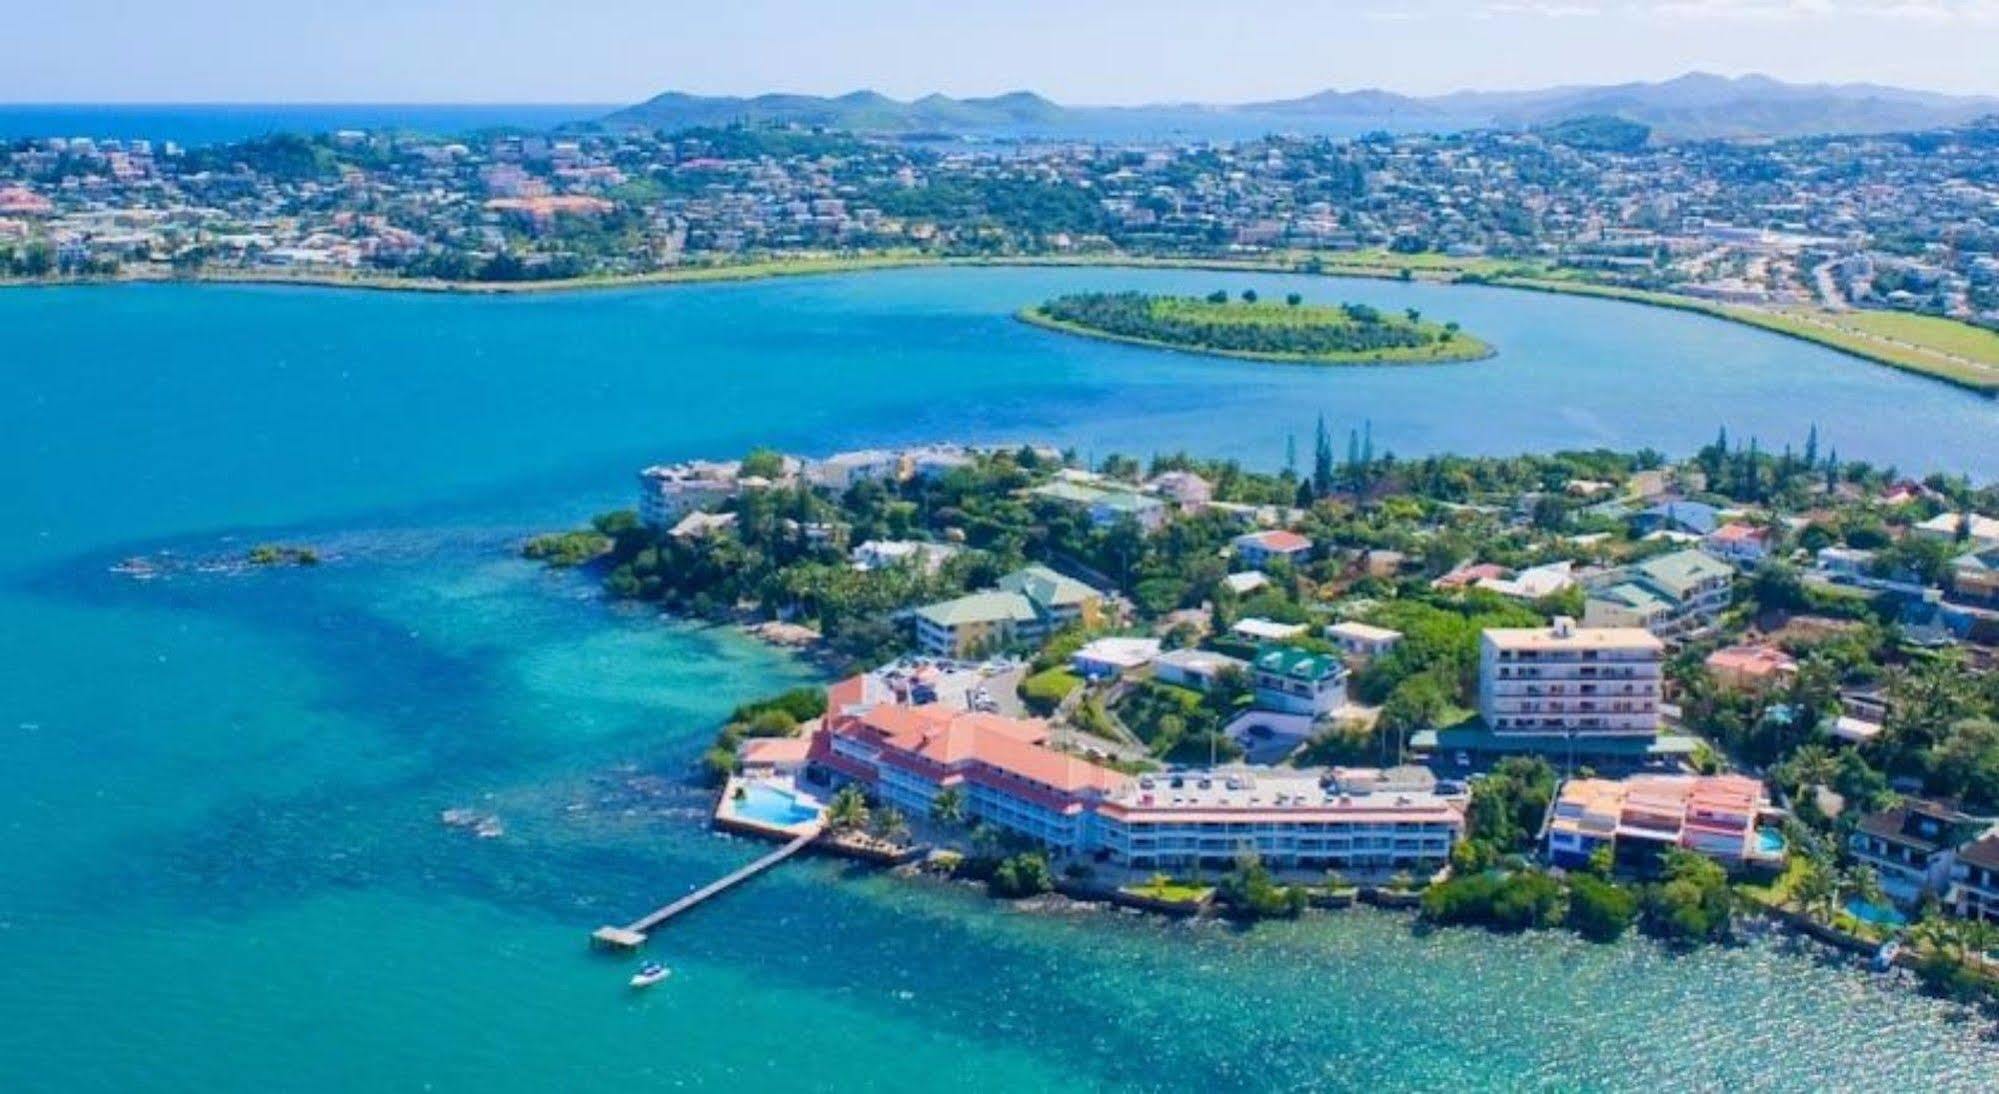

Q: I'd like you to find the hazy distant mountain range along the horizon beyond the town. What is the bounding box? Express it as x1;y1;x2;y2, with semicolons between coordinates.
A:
600;72;1999;140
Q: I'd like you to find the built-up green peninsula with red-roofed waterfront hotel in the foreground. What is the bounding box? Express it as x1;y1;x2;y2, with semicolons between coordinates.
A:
539;436;1999;1012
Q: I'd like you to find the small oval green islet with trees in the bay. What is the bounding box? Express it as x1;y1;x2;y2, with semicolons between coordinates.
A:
1019;290;1493;364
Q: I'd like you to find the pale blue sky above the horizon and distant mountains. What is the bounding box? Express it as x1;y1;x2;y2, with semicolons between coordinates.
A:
11;0;1999;104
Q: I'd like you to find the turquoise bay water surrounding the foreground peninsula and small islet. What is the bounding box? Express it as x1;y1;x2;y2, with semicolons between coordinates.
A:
0;270;1999;1090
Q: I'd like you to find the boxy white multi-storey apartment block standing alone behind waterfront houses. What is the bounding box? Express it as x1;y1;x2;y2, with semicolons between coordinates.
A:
1479;616;1665;740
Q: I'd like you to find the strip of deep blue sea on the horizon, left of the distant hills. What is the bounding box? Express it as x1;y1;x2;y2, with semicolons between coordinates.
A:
0;102;616;148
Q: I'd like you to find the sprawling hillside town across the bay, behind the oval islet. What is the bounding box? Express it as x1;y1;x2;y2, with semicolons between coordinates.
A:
0;118;1999;326
